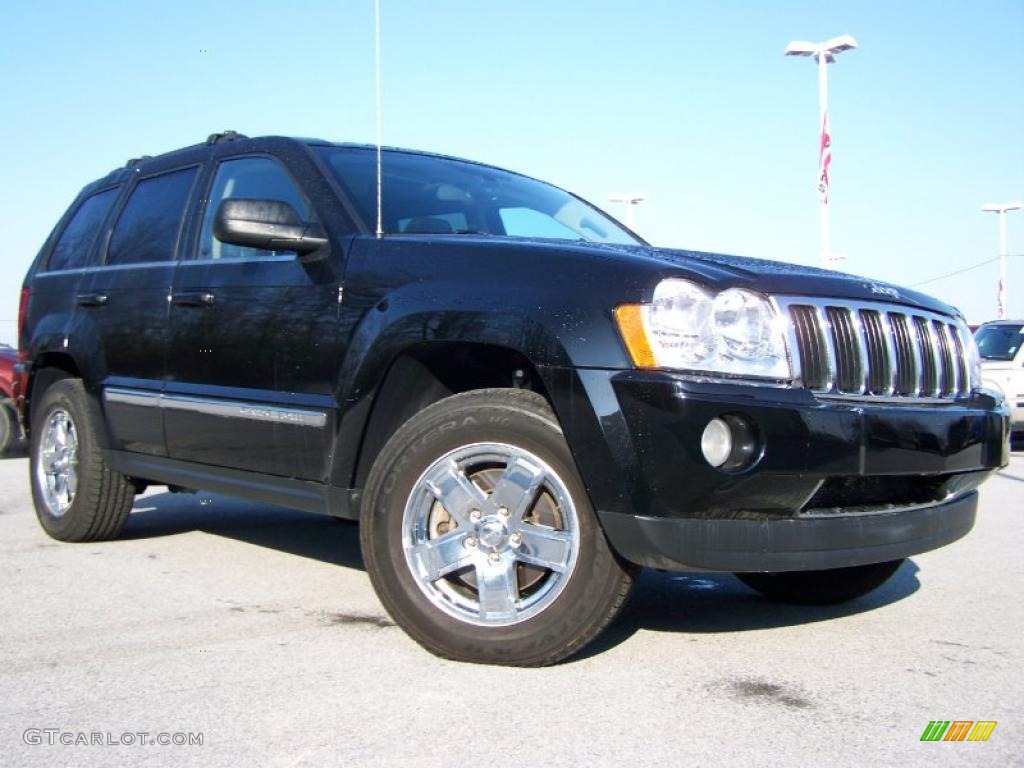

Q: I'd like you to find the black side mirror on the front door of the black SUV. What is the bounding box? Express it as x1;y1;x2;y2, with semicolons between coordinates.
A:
213;198;328;260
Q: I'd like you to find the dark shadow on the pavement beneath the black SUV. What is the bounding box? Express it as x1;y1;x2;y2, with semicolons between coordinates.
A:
121;493;920;662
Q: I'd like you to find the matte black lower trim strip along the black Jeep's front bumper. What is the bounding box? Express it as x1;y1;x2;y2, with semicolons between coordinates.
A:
598;492;978;572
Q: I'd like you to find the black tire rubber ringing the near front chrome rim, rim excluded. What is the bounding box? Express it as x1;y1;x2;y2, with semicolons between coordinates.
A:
362;399;617;663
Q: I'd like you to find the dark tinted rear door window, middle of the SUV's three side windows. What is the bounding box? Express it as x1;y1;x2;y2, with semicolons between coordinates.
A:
106;168;196;264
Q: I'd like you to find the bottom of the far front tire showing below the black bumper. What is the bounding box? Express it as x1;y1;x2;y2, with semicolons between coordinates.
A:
736;560;903;605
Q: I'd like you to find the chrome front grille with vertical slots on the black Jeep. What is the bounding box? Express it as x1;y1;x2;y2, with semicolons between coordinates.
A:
776;297;970;399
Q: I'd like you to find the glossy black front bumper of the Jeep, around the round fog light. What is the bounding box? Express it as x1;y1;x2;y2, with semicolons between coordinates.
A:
556;370;1009;571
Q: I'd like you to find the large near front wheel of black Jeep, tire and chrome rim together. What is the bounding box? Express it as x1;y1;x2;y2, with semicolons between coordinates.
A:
359;389;636;667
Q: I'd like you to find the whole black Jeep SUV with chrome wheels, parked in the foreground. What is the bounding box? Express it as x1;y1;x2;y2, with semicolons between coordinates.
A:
16;132;1008;665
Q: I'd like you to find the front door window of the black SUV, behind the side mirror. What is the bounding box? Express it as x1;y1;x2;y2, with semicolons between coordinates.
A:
196;158;312;259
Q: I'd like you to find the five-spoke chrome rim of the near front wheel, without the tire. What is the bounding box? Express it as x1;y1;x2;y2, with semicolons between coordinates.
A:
402;442;580;627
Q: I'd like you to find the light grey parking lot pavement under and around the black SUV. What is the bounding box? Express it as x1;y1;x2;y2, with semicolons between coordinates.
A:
0;453;1024;768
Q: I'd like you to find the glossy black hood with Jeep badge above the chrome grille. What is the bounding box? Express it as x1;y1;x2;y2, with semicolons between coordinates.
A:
601;246;958;314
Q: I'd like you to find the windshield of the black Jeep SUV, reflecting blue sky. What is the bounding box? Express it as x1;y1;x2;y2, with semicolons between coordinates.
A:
317;146;641;245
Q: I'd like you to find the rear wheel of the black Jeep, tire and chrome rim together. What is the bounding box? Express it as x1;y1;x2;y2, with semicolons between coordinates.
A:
29;379;135;542
